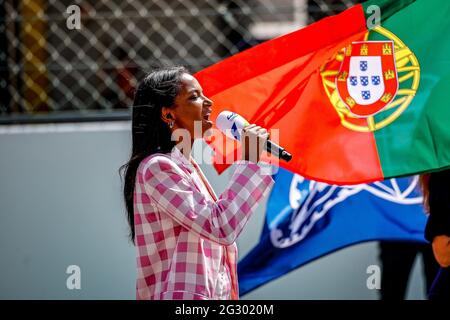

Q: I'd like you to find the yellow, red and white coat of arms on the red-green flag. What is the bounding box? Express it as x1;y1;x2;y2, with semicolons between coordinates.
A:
321;26;420;132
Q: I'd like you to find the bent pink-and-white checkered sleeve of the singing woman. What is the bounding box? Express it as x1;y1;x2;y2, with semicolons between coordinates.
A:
143;156;274;245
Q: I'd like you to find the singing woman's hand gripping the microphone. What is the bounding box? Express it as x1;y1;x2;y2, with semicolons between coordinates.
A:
241;124;269;163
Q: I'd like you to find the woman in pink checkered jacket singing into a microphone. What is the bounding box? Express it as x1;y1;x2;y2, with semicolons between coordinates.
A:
123;67;273;299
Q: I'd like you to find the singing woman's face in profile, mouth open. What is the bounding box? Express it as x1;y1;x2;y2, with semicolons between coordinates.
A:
167;73;213;141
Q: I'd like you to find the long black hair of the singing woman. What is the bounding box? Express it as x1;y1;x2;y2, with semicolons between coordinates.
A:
119;66;189;243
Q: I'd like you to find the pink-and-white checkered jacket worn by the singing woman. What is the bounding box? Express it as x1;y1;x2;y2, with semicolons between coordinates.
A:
134;147;273;300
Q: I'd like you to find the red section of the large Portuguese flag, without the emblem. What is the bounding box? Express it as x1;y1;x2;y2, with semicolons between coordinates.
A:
195;5;382;184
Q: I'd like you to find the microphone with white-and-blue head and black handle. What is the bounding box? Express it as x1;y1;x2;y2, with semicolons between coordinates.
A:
216;111;292;162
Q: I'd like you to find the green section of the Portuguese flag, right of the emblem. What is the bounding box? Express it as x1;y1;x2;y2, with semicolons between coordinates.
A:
371;0;450;177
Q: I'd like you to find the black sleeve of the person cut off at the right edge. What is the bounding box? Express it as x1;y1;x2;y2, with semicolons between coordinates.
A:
425;170;450;242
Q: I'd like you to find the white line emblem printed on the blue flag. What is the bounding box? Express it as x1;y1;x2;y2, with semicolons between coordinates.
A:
269;174;423;248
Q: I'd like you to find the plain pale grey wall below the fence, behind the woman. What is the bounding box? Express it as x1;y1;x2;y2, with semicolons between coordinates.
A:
0;123;424;300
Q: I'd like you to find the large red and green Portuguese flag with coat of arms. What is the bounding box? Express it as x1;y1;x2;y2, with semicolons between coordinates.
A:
195;0;450;184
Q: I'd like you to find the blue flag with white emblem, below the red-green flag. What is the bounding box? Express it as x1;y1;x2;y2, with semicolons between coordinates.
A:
238;168;427;296
